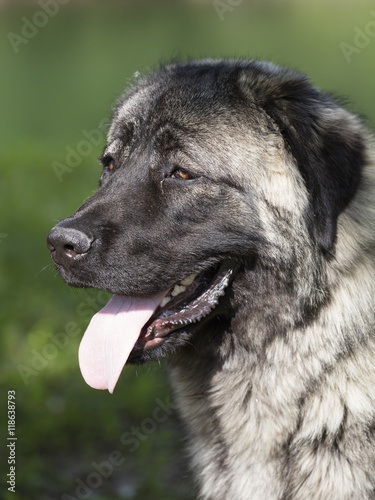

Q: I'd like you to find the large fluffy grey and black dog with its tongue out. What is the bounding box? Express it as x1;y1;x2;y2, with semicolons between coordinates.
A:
48;60;375;500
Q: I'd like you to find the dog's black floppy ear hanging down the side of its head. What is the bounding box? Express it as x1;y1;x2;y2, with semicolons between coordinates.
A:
242;66;365;253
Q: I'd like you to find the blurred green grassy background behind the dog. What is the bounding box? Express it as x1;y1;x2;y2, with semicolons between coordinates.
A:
0;0;375;500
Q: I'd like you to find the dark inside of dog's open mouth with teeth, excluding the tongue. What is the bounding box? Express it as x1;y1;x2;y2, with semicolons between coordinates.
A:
134;262;237;350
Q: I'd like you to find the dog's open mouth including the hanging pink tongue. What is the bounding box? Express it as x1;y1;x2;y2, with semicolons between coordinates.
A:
79;261;239;392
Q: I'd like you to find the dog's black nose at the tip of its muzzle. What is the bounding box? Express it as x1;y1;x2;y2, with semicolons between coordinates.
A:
47;226;93;265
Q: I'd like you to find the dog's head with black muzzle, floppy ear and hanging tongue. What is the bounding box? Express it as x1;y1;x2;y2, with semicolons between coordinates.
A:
48;61;363;391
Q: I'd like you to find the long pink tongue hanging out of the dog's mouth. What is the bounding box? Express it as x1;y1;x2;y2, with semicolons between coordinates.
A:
78;292;166;393
